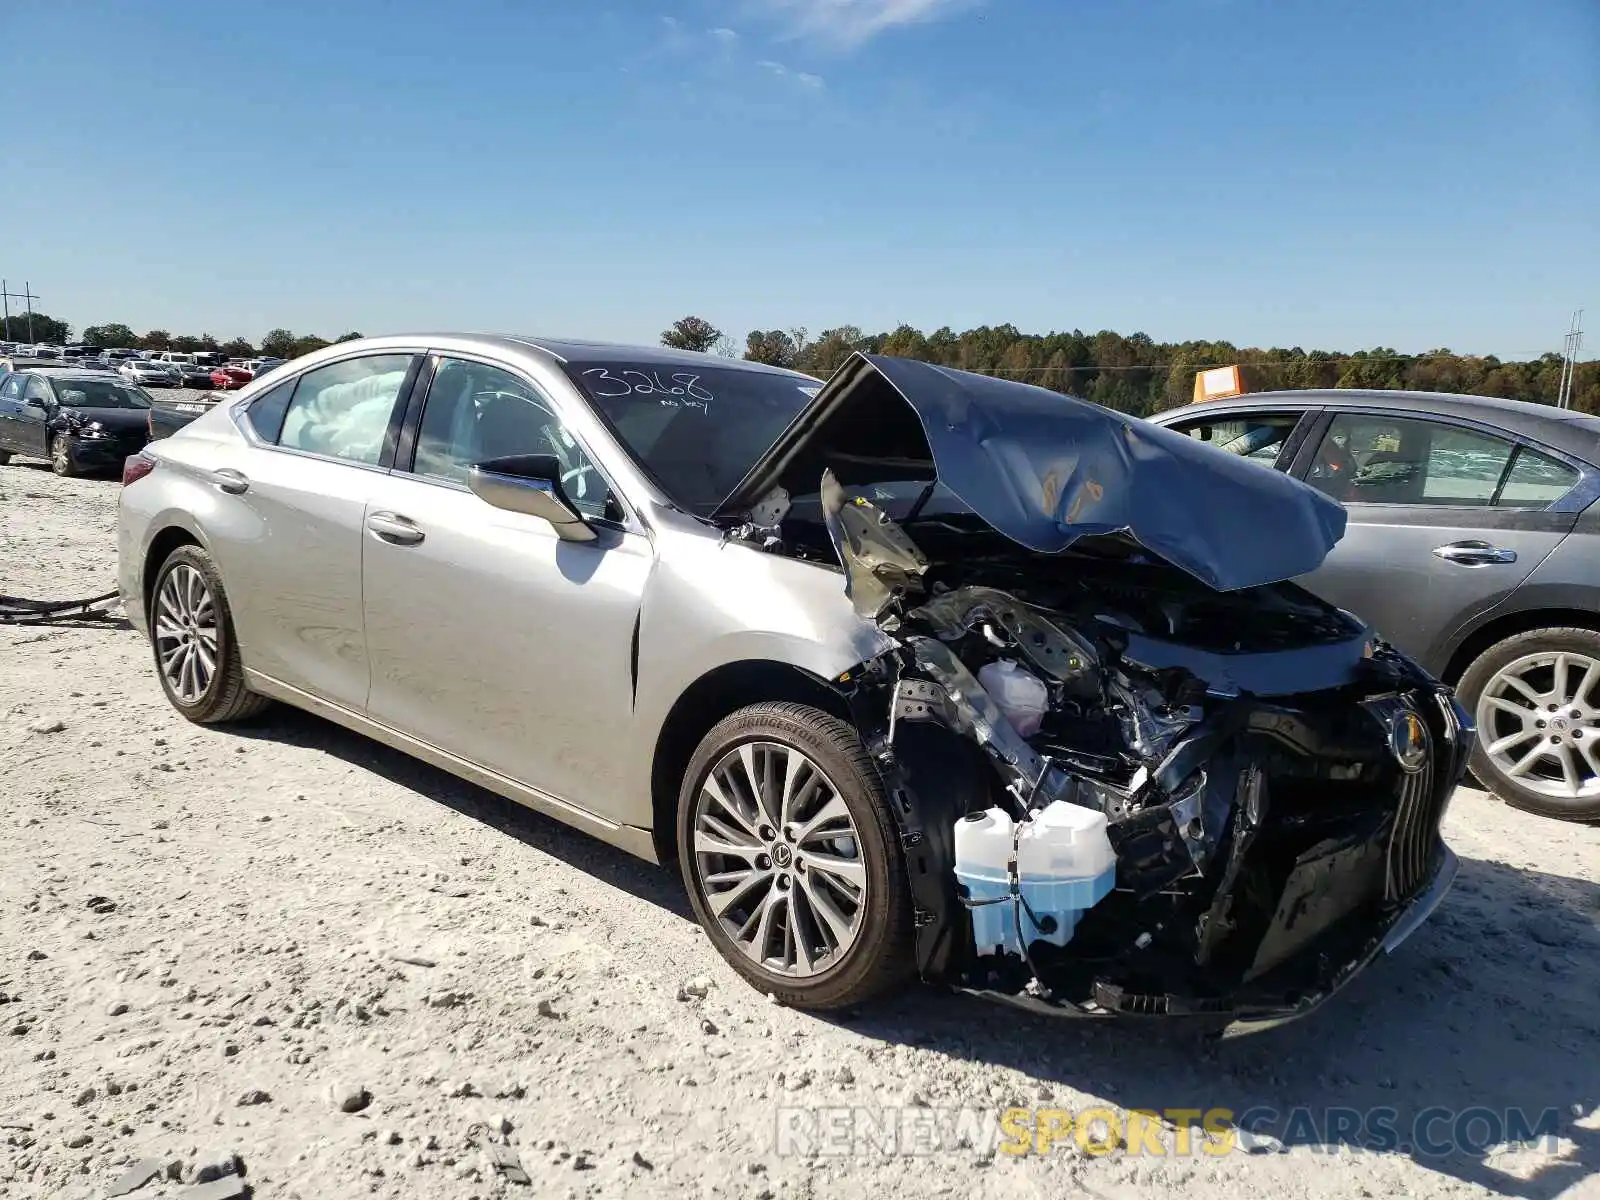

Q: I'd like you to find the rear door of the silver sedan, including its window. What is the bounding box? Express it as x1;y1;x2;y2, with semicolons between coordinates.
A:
214;350;421;712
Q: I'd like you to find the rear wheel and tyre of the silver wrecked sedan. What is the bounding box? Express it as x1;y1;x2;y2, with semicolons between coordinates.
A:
149;546;270;725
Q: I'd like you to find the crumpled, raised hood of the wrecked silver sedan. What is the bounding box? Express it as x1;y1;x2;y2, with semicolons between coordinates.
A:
718;354;1346;592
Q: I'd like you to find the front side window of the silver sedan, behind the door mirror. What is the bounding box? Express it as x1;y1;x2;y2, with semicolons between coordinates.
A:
413;358;622;520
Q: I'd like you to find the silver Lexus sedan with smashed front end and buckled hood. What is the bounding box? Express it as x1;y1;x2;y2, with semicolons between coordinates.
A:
118;334;1474;1032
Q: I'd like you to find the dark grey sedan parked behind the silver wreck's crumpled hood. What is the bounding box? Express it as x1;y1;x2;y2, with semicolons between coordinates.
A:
1154;390;1600;821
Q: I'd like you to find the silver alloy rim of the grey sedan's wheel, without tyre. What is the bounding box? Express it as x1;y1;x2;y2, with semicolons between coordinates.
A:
1477;651;1600;798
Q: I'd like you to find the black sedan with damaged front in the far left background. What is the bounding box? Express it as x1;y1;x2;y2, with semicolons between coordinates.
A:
0;366;150;475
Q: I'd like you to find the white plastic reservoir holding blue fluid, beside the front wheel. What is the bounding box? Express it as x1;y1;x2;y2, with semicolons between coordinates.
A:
955;800;1117;954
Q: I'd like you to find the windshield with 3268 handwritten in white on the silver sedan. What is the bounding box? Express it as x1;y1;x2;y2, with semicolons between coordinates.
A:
565;362;821;517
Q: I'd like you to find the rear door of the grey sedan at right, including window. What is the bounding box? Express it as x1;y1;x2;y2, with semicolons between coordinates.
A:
1294;408;1581;674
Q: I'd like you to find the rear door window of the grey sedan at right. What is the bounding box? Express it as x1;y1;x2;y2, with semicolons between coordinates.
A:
1307;413;1517;507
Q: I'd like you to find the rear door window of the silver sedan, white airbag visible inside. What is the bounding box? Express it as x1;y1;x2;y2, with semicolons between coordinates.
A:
278;354;411;466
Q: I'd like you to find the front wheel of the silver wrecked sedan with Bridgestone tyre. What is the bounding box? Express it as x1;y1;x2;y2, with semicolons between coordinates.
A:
678;704;914;1011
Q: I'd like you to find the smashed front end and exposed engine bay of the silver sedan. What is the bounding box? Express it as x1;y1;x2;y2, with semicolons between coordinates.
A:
733;470;1472;1018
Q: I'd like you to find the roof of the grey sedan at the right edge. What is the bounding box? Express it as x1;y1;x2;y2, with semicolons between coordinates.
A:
1160;387;1600;461
